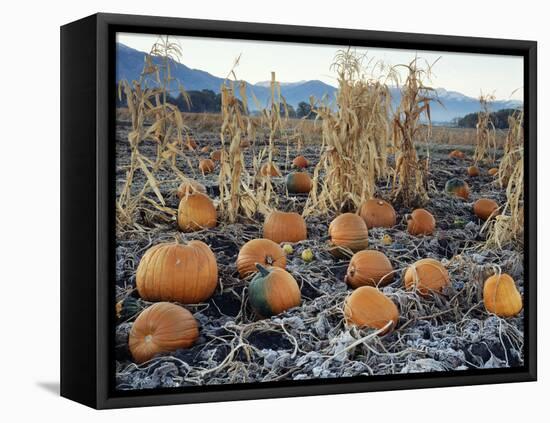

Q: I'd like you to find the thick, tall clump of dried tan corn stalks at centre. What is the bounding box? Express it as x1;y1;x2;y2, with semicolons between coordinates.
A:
304;49;391;215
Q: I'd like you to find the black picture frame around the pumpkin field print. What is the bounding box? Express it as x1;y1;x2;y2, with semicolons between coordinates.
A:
61;13;537;409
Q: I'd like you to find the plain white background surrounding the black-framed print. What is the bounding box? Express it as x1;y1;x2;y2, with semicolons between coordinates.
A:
0;0;550;423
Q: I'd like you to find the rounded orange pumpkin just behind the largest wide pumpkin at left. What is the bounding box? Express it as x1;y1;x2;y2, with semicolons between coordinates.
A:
178;192;217;232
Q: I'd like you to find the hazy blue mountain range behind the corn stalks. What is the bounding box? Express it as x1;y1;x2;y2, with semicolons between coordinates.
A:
116;43;523;122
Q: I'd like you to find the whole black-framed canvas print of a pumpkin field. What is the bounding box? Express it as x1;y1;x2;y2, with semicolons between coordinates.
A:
61;14;536;408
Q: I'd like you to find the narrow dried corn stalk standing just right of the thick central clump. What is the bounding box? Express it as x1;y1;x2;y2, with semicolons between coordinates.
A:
393;58;437;207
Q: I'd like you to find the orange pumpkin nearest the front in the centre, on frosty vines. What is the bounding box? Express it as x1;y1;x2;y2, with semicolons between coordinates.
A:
344;286;399;335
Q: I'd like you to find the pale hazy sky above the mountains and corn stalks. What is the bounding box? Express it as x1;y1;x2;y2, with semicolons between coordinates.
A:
117;33;523;100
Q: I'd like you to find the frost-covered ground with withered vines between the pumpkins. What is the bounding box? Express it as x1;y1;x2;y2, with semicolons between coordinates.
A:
115;124;523;390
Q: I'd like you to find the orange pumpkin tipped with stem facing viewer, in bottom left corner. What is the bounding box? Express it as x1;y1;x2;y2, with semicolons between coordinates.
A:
128;303;199;363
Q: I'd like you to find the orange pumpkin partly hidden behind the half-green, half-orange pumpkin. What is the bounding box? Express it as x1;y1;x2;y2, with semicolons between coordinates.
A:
237;238;286;278
